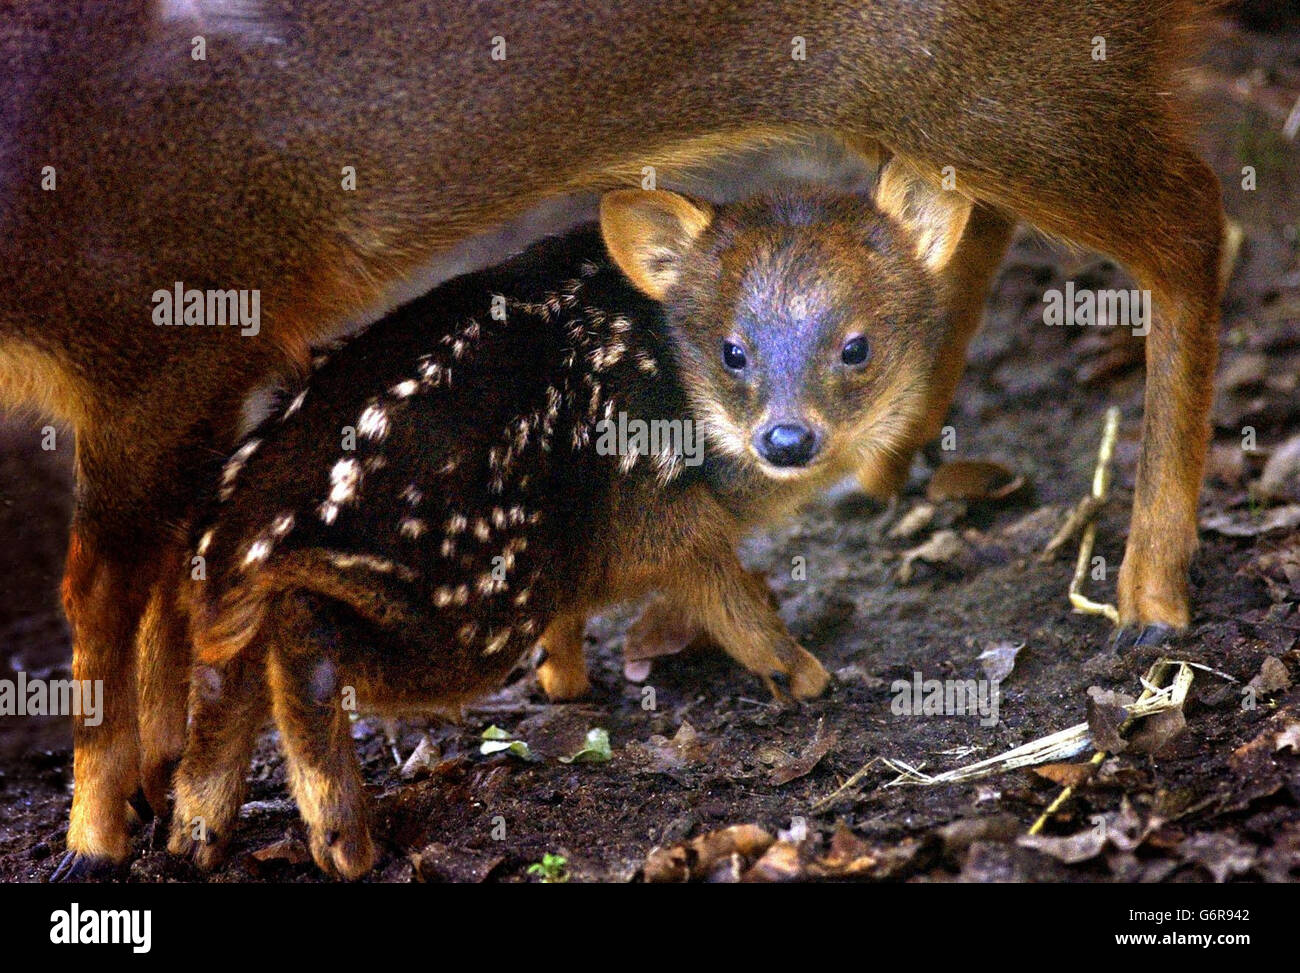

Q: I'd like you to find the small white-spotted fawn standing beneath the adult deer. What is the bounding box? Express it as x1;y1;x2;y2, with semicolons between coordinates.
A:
170;190;952;878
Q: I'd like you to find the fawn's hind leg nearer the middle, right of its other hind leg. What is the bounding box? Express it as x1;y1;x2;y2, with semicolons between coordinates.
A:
267;592;376;878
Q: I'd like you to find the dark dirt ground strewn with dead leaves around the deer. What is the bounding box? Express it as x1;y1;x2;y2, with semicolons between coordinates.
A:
0;15;1300;882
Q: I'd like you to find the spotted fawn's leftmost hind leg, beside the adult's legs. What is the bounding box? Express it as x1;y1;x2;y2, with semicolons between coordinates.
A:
168;645;269;868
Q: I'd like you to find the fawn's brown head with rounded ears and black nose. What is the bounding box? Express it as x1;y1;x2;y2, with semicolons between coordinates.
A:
601;163;970;489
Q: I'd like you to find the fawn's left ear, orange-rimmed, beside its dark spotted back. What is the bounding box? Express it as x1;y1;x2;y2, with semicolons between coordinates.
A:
601;189;714;300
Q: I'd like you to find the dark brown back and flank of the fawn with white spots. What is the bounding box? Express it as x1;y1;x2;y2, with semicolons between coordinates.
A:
188;228;696;700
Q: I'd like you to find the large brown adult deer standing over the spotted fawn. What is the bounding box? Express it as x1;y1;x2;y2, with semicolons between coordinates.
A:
0;0;1222;878
